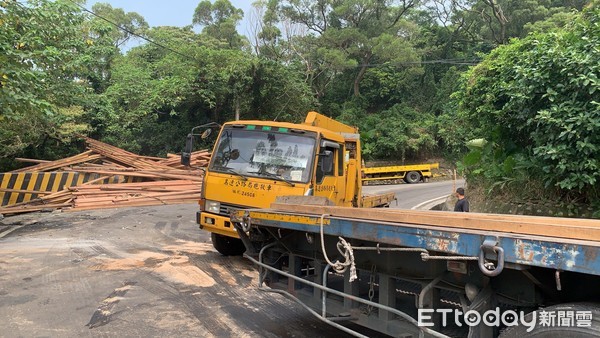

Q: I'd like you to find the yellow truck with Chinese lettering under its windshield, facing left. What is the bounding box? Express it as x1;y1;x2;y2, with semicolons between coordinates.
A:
182;112;395;255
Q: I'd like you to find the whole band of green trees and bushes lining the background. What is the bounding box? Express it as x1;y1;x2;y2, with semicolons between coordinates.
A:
0;0;600;217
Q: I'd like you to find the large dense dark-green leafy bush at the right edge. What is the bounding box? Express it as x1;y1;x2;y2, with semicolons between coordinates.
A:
457;6;600;203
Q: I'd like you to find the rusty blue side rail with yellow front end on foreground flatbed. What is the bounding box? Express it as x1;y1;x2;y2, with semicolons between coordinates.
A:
233;210;600;275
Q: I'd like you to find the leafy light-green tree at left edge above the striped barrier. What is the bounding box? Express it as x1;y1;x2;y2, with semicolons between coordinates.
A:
0;0;90;157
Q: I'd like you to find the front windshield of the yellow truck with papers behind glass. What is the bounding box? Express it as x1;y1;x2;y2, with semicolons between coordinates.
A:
209;126;316;183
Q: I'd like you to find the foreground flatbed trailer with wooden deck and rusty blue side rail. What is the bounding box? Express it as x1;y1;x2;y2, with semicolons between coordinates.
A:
231;204;600;337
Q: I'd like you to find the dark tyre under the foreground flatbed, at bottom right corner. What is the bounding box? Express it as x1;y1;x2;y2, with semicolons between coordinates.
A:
498;303;600;338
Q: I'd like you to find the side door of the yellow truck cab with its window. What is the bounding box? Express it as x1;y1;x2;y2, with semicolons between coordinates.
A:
314;140;346;206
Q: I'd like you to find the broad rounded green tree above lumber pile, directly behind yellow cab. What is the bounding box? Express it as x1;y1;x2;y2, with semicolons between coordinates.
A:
98;22;312;154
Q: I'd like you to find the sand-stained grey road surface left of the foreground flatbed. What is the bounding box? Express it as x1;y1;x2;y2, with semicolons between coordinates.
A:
0;204;390;337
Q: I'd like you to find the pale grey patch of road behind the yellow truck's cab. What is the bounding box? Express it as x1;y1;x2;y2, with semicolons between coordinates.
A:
363;180;465;209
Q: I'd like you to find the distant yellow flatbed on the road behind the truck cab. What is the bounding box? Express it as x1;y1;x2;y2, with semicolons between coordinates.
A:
362;163;440;183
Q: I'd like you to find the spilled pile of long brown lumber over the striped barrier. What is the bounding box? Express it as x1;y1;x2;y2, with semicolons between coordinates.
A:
0;138;210;215
